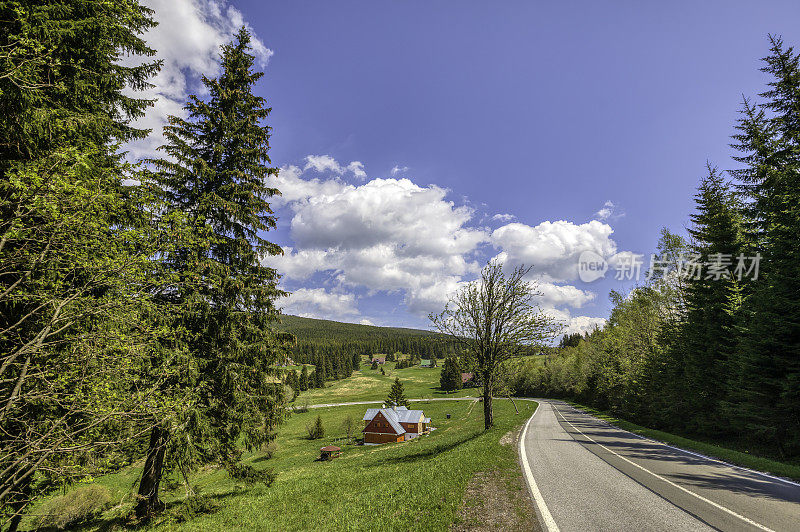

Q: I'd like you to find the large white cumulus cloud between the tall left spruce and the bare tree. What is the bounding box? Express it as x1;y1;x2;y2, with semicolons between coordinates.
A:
264;156;488;315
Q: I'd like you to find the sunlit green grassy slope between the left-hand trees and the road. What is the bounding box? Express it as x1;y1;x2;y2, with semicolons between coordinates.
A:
27;398;536;531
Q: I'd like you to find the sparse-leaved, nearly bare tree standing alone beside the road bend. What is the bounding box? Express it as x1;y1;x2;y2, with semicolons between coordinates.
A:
429;260;561;429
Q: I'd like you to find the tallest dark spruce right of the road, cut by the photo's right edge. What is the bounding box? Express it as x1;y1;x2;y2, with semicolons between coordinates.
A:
732;36;800;457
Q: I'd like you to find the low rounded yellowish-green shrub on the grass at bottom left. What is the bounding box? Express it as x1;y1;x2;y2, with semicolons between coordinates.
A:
38;484;111;529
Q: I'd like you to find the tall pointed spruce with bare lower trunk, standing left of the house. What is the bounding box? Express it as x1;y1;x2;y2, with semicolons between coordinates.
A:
136;28;284;516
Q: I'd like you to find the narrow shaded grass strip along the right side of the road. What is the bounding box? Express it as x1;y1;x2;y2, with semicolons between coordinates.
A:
567;401;800;480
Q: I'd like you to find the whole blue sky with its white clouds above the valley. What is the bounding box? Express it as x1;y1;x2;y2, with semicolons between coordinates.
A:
128;0;800;330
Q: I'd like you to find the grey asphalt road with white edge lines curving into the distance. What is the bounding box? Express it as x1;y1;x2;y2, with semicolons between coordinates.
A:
520;400;800;532
